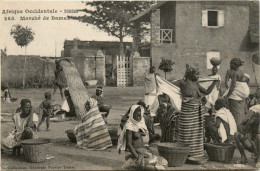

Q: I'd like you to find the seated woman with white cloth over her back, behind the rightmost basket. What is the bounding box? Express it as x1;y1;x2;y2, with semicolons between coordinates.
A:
206;99;237;143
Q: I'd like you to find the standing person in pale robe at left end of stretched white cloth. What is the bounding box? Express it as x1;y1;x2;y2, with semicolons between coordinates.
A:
144;66;159;121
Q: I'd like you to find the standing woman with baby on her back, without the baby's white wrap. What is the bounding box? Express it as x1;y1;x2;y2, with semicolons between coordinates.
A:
226;58;245;125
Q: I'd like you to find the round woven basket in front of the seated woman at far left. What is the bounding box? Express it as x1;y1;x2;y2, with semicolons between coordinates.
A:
21;138;50;163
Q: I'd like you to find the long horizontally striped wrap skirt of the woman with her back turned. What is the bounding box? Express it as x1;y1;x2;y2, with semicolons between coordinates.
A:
178;100;204;157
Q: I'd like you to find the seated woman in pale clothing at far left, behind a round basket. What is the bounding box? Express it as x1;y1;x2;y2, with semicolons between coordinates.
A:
2;99;38;155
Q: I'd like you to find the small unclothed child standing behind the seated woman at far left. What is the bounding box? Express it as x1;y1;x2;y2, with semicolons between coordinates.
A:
38;92;53;131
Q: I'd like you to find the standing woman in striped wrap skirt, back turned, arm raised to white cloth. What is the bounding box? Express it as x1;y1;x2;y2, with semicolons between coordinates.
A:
179;67;218;161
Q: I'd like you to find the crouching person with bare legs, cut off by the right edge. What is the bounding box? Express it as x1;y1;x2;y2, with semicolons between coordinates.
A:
235;104;260;168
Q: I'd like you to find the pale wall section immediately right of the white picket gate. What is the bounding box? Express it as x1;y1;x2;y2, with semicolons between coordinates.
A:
132;52;150;86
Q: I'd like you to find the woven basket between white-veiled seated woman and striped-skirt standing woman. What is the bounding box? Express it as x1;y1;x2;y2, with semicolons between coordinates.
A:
157;142;190;167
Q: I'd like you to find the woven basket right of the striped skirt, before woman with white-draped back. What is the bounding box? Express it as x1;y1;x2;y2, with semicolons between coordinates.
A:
205;143;235;163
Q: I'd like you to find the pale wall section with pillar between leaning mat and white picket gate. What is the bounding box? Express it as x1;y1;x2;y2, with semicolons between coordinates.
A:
71;49;106;85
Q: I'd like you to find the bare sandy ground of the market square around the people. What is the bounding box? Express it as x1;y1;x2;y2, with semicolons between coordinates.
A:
1;87;256;170
